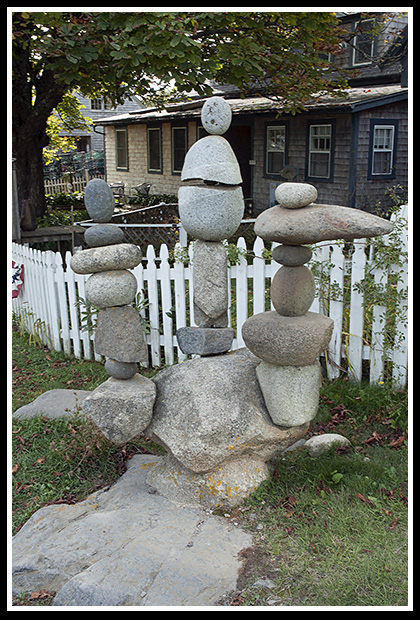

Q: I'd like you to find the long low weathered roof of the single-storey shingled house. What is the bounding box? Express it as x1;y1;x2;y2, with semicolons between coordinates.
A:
95;84;408;125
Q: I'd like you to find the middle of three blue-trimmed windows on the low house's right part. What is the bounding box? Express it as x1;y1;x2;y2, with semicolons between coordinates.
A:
307;123;333;180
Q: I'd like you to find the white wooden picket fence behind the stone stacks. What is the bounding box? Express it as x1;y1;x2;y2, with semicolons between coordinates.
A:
12;207;408;385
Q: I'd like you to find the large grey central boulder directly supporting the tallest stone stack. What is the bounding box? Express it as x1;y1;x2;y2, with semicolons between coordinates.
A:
145;349;307;473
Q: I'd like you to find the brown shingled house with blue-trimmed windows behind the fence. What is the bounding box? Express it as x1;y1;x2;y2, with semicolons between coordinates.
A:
97;13;408;213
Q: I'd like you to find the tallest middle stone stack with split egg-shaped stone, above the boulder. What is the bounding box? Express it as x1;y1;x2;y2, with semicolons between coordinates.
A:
177;97;244;356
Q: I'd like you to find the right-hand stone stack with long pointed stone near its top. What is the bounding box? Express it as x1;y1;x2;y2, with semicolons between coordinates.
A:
242;183;392;428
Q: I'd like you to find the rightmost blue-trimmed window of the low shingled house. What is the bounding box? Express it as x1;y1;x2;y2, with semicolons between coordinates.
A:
368;119;398;178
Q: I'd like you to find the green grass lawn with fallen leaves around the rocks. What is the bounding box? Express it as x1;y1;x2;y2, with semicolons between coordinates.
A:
11;332;409;607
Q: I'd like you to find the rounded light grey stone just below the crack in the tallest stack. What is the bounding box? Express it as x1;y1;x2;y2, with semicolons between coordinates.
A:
178;186;245;241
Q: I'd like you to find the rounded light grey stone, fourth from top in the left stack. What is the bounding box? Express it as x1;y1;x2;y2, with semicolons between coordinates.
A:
85;270;137;308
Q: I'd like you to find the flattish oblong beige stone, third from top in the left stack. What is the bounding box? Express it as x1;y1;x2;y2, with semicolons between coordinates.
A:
70;243;142;274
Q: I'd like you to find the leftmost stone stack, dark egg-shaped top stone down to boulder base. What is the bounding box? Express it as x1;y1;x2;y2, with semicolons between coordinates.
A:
70;179;156;443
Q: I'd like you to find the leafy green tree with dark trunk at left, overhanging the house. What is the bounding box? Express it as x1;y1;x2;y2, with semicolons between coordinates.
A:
12;12;345;228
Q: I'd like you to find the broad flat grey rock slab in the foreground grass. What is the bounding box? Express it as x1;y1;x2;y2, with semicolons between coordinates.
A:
13;455;252;607
